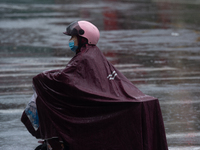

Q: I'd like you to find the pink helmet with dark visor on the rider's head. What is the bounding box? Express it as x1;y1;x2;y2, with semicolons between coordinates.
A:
64;21;100;45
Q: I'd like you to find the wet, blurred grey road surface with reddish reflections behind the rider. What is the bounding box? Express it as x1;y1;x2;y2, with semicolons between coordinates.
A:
0;0;200;150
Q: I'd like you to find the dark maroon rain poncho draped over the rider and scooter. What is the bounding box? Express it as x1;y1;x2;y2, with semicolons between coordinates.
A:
22;45;168;150
